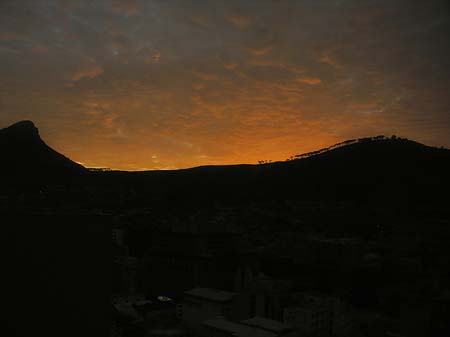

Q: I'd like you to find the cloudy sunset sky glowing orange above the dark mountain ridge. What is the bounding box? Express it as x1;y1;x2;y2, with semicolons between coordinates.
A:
0;0;450;170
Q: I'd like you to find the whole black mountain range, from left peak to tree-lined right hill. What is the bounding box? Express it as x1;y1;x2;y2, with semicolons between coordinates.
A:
0;121;450;204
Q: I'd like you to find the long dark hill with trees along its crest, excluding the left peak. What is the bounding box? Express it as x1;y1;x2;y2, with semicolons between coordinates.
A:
88;138;450;204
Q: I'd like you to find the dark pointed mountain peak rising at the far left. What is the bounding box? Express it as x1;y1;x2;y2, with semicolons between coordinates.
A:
0;121;87;183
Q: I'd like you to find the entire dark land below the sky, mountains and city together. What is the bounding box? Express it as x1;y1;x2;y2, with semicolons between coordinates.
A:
0;124;450;337
